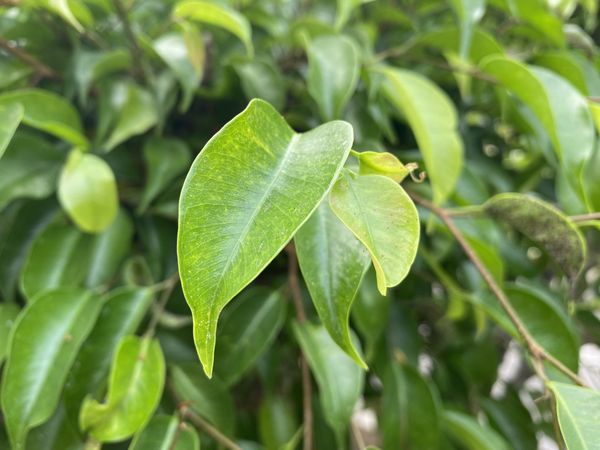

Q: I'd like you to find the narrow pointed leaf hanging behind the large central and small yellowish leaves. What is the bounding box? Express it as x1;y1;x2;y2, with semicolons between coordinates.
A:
294;201;371;369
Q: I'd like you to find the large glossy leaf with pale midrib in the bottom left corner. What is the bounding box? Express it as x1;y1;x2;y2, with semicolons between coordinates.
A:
2;289;102;450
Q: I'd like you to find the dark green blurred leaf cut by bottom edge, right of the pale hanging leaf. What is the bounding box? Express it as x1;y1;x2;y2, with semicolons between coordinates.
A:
381;361;441;450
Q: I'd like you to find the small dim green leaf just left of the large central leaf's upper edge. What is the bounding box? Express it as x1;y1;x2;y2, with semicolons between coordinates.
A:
138;138;191;213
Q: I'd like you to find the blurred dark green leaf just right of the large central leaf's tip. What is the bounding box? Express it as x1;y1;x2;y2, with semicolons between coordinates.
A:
215;287;286;386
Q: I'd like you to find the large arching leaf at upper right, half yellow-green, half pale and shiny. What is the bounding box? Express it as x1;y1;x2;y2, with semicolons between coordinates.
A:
481;55;595;200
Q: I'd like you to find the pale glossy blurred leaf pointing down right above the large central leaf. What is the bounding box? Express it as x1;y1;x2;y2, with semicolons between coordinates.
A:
306;36;359;120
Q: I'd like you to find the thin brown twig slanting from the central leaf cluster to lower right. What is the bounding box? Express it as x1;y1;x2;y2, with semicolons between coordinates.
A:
411;193;587;386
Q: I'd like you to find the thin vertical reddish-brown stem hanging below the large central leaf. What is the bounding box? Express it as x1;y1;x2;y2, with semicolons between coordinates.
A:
286;243;313;450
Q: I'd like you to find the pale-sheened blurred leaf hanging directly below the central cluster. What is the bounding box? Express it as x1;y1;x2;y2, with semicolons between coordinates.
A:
294;322;364;444
